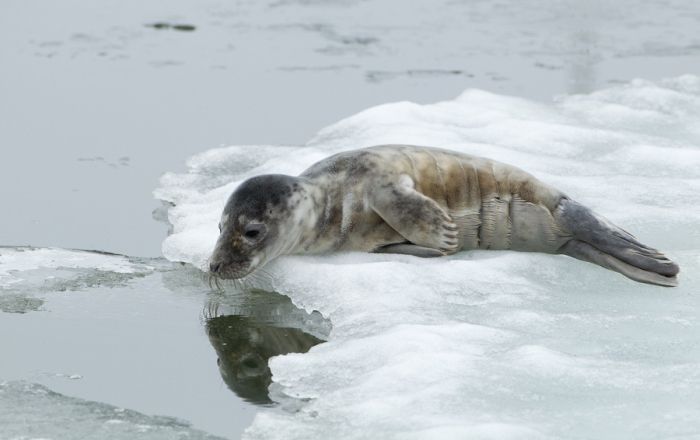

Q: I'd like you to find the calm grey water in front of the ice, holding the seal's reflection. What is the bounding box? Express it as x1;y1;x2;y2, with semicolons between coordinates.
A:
0;248;330;438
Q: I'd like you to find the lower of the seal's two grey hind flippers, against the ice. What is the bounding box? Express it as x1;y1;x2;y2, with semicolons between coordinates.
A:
561;240;678;287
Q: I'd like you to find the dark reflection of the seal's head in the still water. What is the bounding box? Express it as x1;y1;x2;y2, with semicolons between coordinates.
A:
206;292;326;405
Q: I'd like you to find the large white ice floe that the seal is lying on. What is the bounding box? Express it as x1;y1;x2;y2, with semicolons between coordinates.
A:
156;75;700;439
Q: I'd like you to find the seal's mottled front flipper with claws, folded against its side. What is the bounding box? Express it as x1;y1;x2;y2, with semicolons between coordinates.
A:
368;175;459;253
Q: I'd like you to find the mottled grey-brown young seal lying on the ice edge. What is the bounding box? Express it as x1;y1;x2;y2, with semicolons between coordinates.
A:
210;145;679;286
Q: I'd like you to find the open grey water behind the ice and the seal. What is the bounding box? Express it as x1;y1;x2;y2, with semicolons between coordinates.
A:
0;0;700;256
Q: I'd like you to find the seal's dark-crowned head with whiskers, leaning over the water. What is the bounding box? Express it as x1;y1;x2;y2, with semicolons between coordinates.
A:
209;174;311;279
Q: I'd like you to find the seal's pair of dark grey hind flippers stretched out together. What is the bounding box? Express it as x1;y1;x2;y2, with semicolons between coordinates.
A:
555;198;679;287
